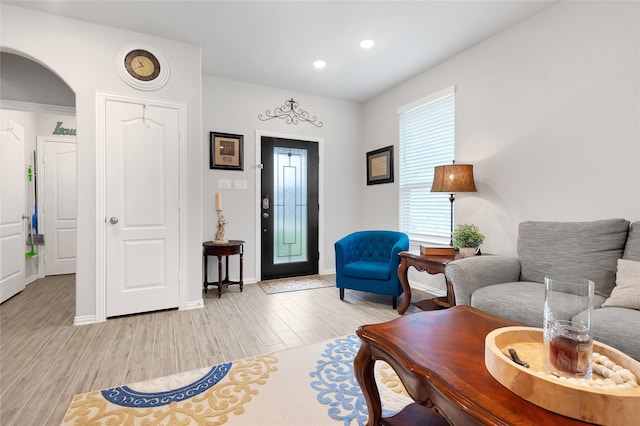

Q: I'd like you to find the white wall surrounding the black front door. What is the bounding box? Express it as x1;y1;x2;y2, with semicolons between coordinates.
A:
201;76;365;282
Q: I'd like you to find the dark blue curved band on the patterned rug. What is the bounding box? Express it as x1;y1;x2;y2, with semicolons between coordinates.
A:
101;362;233;407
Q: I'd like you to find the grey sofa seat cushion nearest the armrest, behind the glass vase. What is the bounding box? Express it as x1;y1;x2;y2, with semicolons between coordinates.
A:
471;281;605;328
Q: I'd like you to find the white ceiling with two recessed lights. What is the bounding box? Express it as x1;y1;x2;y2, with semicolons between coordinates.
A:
0;0;557;102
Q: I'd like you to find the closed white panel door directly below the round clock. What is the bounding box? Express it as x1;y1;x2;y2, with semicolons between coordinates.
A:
105;100;180;317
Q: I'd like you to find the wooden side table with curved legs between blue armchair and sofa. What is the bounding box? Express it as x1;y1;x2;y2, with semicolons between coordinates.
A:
398;251;461;315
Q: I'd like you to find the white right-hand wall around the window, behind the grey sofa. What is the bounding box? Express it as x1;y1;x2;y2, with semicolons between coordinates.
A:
360;2;640;255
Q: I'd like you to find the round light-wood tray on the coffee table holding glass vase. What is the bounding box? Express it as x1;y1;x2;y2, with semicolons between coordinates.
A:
484;327;640;426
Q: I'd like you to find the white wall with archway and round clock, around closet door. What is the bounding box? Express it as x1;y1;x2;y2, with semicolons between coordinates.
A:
0;4;202;321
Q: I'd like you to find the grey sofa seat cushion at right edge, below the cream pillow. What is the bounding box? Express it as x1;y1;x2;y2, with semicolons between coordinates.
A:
577;308;640;361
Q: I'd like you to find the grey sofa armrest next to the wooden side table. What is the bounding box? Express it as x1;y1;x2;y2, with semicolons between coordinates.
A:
445;256;520;305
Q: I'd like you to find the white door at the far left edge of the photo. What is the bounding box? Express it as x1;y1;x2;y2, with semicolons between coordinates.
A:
0;121;25;303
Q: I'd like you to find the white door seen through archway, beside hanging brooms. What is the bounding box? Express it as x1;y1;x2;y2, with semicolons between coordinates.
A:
38;137;76;275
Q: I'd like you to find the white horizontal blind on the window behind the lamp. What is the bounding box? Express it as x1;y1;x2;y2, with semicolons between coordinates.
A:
398;87;455;243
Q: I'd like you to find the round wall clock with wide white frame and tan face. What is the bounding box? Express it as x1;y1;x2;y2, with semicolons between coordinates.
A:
116;45;169;90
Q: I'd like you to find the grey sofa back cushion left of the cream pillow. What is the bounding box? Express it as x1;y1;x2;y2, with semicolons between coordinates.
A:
518;219;629;297
